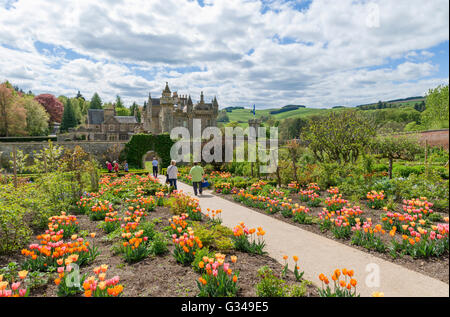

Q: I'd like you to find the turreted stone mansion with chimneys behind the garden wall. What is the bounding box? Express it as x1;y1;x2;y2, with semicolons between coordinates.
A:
58;83;219;141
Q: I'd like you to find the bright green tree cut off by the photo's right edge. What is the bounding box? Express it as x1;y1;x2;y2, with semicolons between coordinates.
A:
422;85;449;129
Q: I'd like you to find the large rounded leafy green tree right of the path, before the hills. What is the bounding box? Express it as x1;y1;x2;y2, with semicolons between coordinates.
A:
303;110;375;163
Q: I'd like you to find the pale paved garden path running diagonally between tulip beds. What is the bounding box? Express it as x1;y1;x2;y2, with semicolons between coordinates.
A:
161;176;449;297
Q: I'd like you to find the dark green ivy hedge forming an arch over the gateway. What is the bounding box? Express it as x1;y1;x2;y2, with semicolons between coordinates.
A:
120;133;175;168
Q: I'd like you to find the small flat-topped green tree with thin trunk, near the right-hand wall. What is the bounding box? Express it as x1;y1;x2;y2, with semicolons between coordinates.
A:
370;136;423;179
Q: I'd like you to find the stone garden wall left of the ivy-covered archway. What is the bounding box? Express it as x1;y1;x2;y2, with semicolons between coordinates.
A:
0;141;126;167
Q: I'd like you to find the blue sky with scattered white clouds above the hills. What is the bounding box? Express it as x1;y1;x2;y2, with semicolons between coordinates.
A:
0;0;449;109
